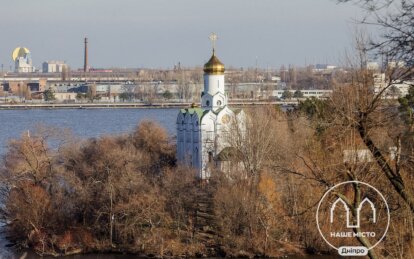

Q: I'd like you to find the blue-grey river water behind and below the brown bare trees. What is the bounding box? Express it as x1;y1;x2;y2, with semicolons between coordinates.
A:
0;109;339;259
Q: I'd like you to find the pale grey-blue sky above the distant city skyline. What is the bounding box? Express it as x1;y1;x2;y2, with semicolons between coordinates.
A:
0;0;362;68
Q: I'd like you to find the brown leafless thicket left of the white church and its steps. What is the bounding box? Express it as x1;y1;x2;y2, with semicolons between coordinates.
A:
1;122;199;255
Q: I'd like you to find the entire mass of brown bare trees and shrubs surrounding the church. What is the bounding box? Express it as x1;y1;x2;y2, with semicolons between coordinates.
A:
0;48;414;258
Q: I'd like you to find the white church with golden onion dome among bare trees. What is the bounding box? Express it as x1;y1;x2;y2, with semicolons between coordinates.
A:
177;48;245;180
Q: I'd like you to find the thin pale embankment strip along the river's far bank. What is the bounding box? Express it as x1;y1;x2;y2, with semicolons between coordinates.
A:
0;101;298;110
